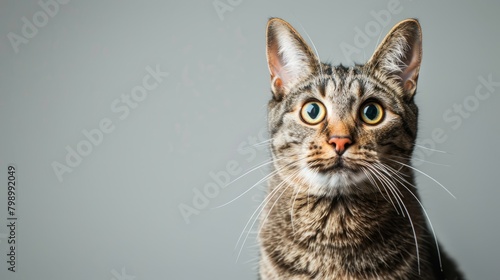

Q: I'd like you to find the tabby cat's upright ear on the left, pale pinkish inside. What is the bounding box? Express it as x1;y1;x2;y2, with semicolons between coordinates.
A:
266;18;318;100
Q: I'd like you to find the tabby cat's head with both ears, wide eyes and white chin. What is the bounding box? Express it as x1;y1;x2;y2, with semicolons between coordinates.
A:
267;18;422;195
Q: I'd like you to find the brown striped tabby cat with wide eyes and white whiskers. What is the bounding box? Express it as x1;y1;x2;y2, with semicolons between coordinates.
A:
258;18;464;280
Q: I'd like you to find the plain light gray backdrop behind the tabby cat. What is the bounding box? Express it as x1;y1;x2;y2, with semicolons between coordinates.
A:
0;0;500;280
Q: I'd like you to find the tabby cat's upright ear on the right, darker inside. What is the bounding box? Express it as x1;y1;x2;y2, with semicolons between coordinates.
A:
368;19;422;98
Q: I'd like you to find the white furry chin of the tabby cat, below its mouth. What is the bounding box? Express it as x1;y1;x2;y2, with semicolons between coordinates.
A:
301;168;369;196
